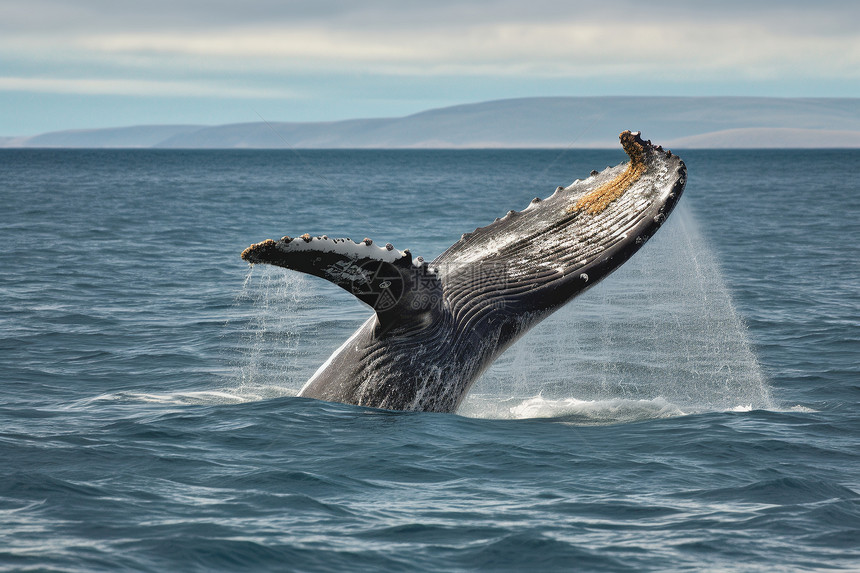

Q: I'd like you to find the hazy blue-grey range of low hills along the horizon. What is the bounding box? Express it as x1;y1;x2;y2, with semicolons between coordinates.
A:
5;97;860;149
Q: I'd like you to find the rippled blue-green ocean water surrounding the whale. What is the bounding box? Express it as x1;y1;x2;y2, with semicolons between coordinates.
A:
0;146;860;571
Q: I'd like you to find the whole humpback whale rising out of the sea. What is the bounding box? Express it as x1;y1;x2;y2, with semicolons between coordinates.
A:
242;131;687;412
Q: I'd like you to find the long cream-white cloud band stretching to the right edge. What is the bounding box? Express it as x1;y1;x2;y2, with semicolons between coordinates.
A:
74;22;860;78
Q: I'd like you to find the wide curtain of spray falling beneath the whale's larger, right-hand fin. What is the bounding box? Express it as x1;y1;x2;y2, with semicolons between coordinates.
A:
459;204;774;423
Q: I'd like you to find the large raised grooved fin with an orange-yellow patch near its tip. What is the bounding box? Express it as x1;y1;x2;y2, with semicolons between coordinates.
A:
432;131;686;324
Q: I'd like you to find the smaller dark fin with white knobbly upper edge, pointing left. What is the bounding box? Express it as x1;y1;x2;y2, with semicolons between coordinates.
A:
242;235;442;324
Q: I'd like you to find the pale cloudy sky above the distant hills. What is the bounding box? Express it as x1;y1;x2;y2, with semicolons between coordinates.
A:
0;0;860;136
